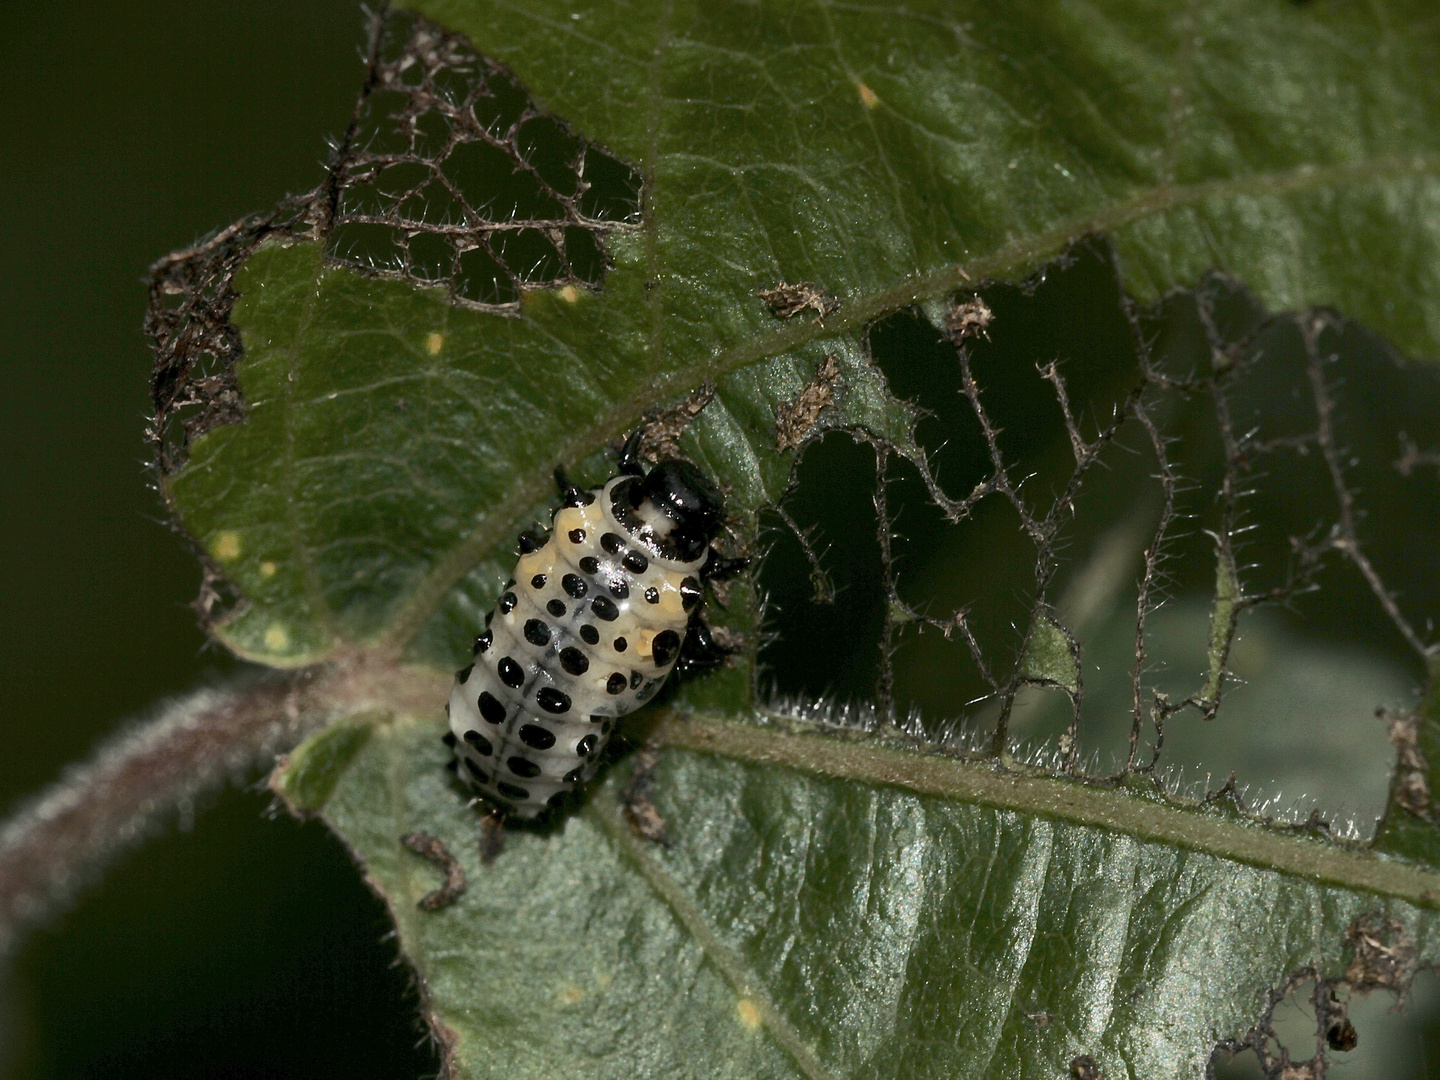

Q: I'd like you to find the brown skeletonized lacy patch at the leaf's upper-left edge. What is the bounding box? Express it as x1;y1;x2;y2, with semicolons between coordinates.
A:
145;13;641;474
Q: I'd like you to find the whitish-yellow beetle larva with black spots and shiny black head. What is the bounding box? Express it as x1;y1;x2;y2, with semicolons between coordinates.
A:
446;462;720;819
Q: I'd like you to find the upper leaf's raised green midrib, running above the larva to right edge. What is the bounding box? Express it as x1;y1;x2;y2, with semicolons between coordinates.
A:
374;156;1440;658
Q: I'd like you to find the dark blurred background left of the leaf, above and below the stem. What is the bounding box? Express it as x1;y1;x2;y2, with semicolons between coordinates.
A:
0;0;436;1077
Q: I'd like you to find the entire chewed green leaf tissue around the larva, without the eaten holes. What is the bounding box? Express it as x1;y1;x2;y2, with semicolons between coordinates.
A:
146;0;1440;1079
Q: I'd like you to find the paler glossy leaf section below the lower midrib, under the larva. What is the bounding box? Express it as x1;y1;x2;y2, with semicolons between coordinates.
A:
275;717;1440;1077
